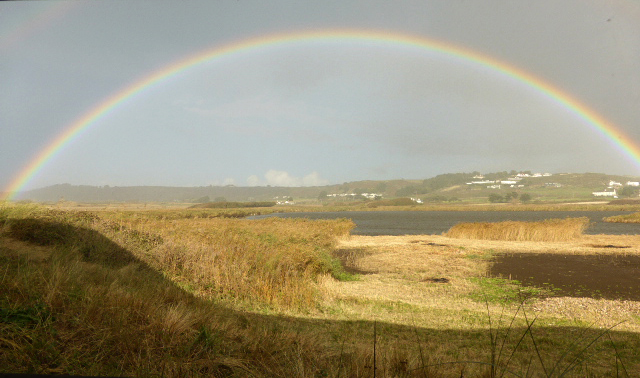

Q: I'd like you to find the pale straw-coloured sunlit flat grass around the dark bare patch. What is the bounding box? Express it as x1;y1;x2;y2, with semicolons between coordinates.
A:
324;235;640;326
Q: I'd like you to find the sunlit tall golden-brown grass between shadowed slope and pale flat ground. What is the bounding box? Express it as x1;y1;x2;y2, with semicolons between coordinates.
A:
93;213;353;309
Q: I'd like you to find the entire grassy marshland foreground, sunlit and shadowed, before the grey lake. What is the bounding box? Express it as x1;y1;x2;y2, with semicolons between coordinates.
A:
0;205;640;377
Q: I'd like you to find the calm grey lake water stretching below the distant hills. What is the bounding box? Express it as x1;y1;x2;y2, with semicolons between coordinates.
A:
250;211;640;236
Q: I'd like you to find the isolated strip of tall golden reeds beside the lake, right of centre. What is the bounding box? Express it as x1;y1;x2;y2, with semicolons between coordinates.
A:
445;217;589;242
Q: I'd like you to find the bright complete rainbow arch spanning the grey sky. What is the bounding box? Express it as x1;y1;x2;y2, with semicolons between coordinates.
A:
4;30;640;200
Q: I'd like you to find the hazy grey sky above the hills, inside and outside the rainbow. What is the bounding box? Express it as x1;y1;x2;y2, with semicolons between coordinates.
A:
0;0;640;192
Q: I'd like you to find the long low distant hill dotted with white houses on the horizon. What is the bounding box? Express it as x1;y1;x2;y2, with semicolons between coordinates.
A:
10;171;640;203
